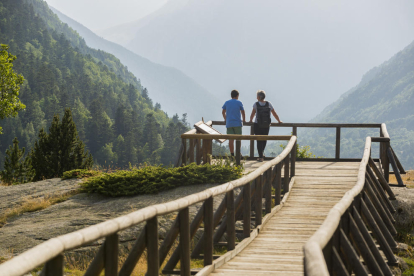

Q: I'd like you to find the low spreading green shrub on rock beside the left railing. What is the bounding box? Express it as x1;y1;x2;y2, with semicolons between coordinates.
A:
81;163;243;197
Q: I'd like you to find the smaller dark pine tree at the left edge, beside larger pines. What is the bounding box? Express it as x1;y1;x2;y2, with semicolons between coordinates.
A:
0;137;33;185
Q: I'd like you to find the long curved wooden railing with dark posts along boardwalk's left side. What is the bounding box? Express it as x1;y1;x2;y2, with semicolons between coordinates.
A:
0;136;296;276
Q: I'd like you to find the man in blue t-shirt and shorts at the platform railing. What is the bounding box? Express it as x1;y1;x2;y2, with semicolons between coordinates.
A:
222;90;246;156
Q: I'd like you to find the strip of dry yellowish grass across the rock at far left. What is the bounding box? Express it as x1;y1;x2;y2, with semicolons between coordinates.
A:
0;190;79;228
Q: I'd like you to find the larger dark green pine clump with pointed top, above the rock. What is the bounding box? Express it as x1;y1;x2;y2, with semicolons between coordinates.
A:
30;108;93;180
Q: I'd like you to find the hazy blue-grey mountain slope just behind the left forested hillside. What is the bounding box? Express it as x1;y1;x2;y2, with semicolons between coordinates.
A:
51;5;221;123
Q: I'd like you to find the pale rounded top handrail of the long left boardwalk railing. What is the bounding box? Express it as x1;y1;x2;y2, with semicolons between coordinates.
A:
0;136;296;276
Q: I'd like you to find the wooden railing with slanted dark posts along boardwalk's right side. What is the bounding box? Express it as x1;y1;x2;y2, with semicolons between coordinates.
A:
304;124;404;276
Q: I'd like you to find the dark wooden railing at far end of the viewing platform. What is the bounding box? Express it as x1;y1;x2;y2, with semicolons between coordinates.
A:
207;121;405;187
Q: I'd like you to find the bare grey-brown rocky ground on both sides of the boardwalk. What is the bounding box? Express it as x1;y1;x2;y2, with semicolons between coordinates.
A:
0;172;414;275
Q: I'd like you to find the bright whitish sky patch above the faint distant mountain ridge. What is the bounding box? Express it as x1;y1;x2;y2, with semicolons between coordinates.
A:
45;0;168;31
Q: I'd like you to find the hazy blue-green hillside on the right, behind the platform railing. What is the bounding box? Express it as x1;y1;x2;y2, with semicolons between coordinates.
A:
299;39;414;169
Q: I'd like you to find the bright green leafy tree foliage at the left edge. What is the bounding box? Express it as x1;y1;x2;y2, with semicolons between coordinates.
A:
0;44;26;133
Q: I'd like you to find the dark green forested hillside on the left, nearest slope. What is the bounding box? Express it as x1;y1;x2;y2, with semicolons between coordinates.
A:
0;0;186;167
